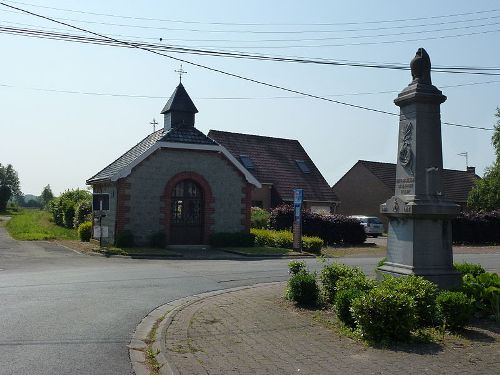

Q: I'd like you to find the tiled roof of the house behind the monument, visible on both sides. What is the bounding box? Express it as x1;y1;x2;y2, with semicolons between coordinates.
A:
358;160;480;202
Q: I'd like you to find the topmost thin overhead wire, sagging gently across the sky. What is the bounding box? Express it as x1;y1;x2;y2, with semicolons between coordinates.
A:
5;1;500;26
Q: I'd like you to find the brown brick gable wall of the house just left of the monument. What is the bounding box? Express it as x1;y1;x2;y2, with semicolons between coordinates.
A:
332;164;394;229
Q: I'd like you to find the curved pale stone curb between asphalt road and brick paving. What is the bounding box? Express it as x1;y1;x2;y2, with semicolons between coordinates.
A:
127;281;281;375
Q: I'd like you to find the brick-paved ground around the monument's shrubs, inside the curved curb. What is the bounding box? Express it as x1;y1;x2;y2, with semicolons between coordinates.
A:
163;283;500;374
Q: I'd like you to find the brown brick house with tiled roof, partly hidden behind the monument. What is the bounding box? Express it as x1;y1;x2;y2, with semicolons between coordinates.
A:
332;160;479;226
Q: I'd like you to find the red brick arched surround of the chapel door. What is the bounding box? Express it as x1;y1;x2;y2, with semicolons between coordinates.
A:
160;172;215;244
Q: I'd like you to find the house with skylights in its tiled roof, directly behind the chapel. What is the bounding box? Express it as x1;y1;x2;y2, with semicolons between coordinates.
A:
208;130;338;213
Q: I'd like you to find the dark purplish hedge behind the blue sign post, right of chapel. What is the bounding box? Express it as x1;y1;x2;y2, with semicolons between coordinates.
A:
269;205;366;245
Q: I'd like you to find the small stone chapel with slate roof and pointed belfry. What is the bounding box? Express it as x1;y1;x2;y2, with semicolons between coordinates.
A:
87;84;261;245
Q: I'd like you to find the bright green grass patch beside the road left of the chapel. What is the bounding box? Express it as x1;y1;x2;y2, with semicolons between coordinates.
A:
5;209;78;241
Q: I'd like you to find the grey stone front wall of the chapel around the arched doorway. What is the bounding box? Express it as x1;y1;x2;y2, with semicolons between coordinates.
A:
118;149;250;245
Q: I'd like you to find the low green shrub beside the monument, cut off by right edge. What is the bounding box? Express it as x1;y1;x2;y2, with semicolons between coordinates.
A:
462;272;500;321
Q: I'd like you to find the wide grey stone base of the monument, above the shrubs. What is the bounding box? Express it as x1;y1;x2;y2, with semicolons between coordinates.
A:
378;216;461;289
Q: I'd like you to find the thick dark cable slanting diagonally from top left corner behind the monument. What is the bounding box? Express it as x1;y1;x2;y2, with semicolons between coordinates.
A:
0;2;493;130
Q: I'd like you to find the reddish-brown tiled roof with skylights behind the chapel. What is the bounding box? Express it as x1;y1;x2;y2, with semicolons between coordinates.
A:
208;130;338;202
